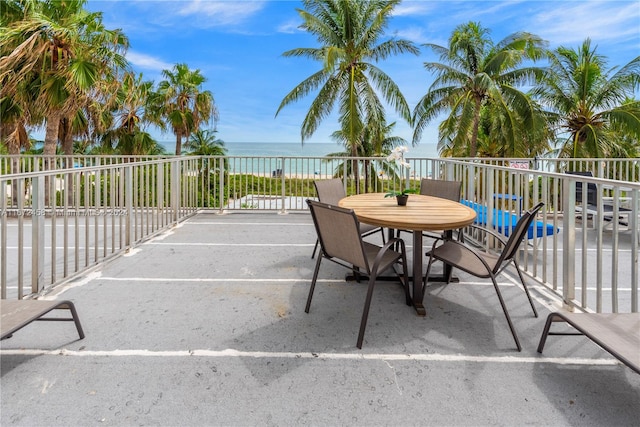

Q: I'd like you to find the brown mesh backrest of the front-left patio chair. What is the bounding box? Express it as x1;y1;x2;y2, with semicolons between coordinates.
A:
307;199;369;272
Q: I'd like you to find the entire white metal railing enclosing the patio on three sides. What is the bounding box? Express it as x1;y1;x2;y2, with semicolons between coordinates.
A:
0;156;640;312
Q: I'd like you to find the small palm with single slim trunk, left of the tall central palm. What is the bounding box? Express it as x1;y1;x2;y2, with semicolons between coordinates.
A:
158;64;218;156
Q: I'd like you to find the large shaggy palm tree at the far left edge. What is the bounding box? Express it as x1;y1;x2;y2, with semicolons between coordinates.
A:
0;0;128;155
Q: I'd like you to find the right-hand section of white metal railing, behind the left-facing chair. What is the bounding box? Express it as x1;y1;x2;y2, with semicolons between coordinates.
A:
432;160;640;312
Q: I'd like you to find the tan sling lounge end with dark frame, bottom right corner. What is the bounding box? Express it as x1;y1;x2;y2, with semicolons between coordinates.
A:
538;312;640;374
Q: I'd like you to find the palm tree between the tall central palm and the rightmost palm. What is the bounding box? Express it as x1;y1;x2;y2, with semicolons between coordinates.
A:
413;22;546;157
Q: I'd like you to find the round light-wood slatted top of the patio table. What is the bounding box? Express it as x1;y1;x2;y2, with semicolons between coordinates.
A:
338;193;476;231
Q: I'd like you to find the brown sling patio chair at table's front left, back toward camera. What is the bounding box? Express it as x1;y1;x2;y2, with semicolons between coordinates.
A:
304;200;411;348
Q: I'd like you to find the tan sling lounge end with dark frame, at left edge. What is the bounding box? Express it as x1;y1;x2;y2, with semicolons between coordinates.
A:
0;299;84;340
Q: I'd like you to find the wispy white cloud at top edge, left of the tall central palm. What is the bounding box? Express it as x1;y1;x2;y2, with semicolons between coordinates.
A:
178;0;265;27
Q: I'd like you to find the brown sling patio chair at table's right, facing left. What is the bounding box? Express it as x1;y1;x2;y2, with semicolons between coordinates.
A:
423;203;544;351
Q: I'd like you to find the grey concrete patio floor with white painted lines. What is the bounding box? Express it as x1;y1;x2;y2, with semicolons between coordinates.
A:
0;212;640;426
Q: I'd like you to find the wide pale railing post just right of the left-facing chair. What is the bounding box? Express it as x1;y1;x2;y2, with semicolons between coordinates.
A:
562;179;586;311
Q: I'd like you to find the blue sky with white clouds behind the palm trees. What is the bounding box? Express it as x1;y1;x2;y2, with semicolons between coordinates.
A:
87;0;640;143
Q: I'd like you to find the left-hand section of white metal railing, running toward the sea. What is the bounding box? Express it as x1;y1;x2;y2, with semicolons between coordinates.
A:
0;158;197;298
